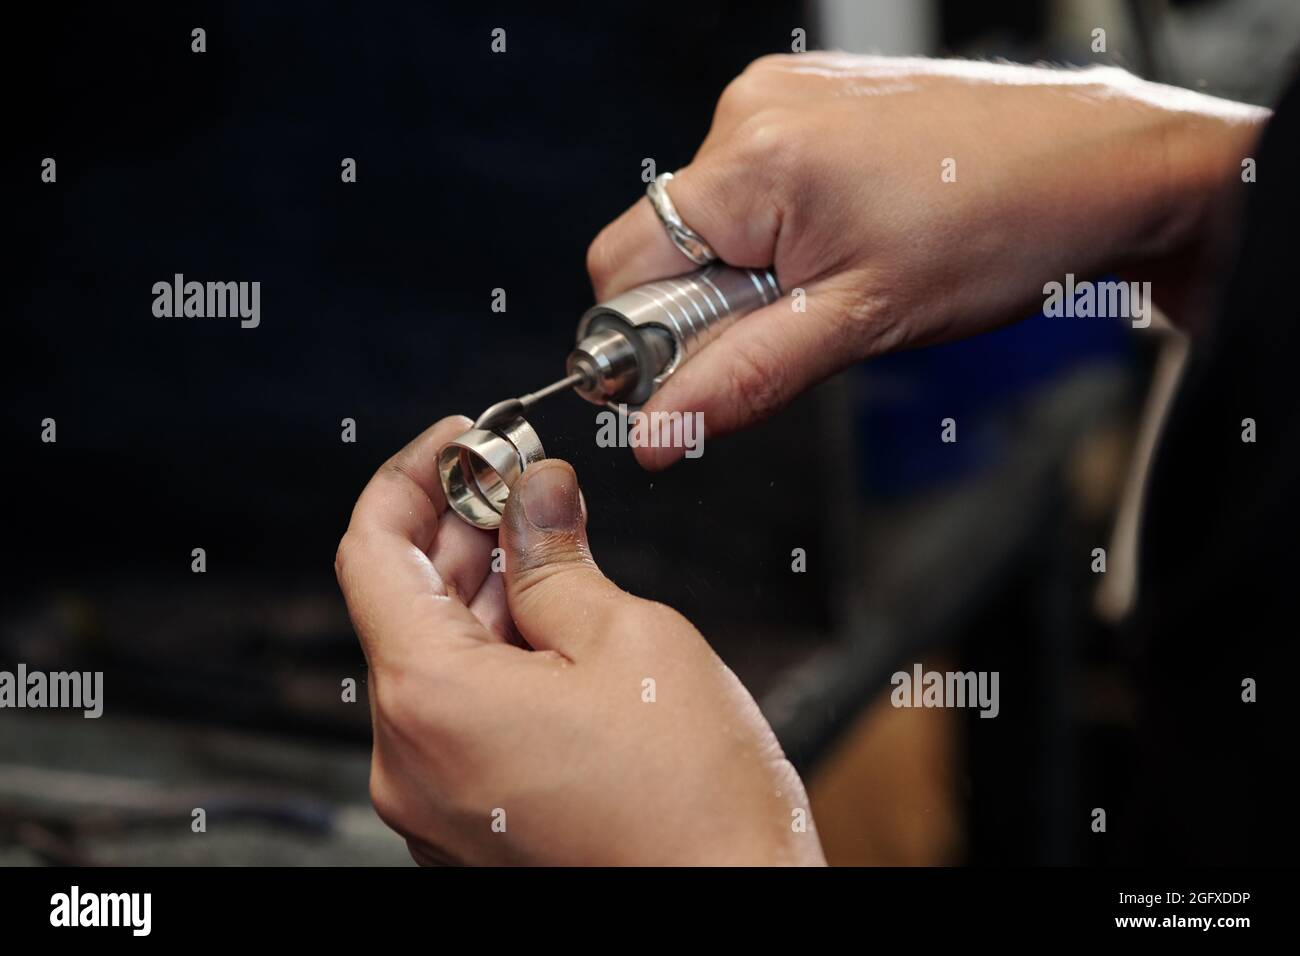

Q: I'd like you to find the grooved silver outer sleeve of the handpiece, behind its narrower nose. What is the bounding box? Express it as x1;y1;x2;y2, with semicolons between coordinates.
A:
577;265;781;388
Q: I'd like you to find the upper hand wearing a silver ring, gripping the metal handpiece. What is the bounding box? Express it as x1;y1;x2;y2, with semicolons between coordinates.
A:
588;53;1268;467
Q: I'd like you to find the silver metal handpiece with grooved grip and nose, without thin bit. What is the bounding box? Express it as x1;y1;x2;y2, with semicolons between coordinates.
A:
566;265;781;406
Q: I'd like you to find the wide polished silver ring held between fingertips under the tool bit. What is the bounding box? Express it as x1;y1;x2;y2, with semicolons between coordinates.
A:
438;415;546;529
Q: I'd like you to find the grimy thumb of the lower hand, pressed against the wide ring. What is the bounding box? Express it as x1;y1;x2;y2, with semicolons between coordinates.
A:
501;458;632;659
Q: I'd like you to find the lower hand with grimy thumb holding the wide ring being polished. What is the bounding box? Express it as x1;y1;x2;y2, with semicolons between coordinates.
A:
335;418;823;864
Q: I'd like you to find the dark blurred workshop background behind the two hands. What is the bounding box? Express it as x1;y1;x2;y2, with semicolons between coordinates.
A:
0;0;1291;862
